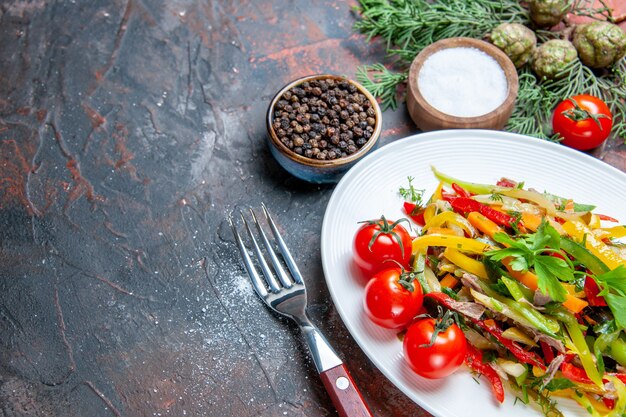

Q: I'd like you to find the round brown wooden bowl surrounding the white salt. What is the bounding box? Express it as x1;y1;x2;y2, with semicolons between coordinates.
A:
407;37;518;131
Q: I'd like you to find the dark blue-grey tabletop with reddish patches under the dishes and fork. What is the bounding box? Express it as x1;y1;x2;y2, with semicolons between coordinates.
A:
0;0;626;417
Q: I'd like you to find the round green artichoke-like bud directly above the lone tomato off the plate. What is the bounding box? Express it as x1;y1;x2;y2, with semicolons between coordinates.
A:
532;39;578;79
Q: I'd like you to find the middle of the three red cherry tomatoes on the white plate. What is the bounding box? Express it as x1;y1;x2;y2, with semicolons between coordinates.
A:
363;267;424;329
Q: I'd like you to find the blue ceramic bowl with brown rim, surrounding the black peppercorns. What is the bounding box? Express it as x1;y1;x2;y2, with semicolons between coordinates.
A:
266;74;382;184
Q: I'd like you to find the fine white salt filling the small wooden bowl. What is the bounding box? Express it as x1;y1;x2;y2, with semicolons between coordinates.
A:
417;47;508;117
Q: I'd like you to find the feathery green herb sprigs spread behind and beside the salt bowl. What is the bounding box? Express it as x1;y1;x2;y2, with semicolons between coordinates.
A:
354;0;626;141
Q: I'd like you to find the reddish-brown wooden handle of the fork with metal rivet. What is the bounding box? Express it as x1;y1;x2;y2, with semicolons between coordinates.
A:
320;364;372;417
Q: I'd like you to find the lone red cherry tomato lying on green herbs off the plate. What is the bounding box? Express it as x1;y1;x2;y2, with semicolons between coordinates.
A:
552;94;613;151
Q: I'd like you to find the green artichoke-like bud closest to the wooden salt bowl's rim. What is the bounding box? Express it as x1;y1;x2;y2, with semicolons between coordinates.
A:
491;23;537;68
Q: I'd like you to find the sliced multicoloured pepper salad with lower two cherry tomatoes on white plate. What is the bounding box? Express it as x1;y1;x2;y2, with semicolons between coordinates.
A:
355;168;626;416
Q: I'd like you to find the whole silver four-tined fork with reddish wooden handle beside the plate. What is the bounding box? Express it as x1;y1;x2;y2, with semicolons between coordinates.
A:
228;204;372;417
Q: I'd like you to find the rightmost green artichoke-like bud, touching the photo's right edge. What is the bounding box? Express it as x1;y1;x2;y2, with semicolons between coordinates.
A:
572;21;626;68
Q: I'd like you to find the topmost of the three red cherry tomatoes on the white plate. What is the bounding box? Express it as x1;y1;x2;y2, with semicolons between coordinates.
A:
353;217;412;280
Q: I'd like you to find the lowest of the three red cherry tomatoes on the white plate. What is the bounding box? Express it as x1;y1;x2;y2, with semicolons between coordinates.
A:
403;318;467;379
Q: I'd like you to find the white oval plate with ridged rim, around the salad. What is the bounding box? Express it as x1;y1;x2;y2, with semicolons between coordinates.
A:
321;130;626;417
